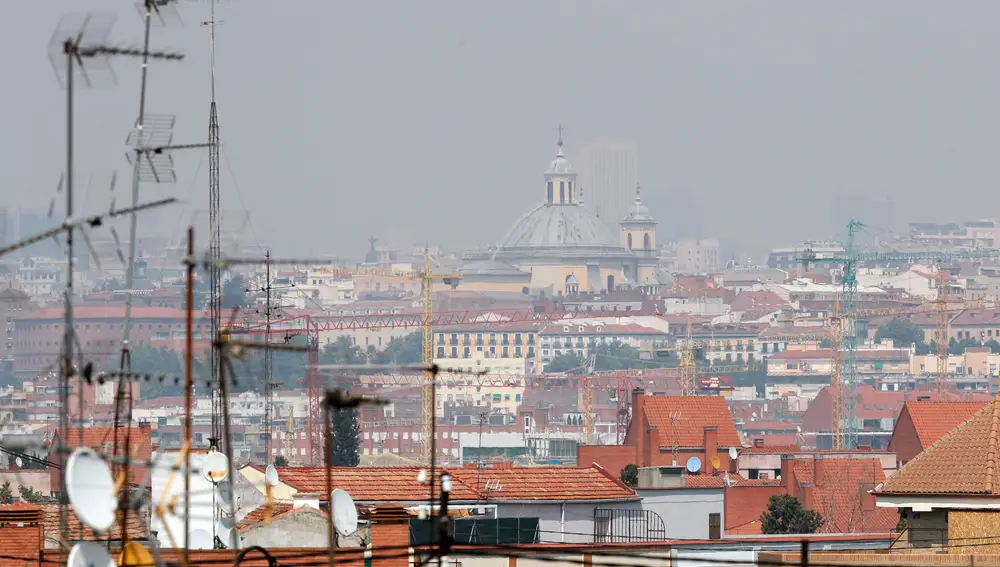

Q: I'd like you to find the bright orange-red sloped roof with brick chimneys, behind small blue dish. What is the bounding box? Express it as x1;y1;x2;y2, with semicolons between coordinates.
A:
643;396;741;447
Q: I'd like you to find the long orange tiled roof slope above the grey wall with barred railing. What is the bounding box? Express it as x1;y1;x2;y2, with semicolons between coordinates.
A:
451;465;638;500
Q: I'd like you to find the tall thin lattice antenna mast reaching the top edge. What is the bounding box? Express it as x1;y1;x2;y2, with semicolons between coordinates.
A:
201;0;223;449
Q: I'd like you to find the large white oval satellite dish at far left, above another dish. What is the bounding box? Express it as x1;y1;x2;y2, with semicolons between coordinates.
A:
66;447;118;533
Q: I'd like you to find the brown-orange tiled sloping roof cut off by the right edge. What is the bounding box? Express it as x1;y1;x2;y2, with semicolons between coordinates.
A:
878;400;1000;495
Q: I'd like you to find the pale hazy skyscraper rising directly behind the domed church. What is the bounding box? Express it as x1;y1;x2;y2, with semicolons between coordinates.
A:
579;141;639;230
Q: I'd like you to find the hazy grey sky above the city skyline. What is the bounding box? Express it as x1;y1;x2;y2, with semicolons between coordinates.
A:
0;0;1000;262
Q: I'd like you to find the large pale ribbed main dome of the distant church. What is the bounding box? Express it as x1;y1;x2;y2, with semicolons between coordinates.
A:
501;204;621;250
